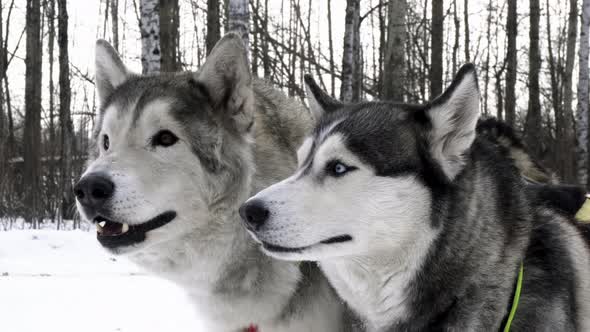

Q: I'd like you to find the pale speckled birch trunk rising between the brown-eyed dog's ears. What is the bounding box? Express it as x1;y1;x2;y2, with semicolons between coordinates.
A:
139;0;161;74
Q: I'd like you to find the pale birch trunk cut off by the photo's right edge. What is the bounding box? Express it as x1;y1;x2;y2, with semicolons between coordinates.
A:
576;0;590;187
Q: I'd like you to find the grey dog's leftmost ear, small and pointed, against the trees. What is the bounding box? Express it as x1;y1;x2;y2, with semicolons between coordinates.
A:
94;39;129;103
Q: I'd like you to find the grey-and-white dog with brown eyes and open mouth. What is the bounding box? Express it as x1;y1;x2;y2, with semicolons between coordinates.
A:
75;34;346;332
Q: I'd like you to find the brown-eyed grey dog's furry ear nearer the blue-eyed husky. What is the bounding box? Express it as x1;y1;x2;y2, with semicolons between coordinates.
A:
195;33;254;133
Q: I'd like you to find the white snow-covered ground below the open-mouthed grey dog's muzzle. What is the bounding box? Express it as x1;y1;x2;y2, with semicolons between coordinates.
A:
0;230;203;332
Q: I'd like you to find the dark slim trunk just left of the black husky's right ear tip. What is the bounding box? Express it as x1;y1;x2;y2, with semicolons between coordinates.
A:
430;0;444;99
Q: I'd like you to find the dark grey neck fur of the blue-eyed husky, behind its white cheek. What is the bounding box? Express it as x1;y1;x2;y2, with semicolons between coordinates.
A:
392;139;530;331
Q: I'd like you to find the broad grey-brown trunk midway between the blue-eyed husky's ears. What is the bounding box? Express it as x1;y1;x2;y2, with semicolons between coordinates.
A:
382;0;407;101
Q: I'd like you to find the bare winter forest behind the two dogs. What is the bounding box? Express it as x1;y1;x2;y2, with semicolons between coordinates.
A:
0;0;590;229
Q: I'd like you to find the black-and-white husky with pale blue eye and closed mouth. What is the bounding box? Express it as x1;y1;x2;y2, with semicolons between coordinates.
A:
240;65;590;331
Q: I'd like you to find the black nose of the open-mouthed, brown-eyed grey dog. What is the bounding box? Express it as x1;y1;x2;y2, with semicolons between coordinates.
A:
74;173;115;209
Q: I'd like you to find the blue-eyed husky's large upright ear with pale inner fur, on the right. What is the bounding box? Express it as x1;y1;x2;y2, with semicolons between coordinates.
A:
426;64;479;180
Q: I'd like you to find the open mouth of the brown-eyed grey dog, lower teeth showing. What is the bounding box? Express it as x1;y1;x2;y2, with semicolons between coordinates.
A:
94;211;176;249
